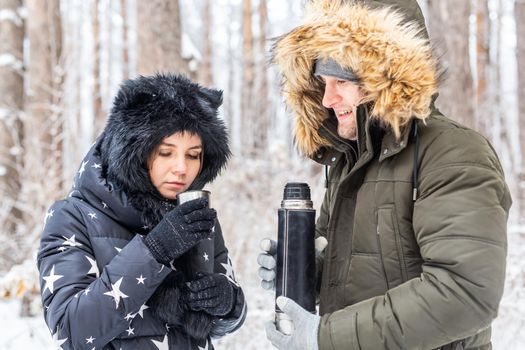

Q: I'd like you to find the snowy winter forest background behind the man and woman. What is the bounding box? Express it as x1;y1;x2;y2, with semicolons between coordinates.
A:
0;0;525;349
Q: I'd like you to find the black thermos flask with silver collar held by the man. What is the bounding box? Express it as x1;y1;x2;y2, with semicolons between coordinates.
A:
275;182;315;334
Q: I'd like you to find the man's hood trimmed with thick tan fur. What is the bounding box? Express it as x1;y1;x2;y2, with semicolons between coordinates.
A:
272;0;440;156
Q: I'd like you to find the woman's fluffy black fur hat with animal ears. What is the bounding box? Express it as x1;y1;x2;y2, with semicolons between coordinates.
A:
99;74;231;217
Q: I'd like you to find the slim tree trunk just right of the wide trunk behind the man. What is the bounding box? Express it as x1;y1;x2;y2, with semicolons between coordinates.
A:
474;0;490;136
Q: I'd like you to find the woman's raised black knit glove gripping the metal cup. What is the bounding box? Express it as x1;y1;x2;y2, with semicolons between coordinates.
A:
144;198;217;265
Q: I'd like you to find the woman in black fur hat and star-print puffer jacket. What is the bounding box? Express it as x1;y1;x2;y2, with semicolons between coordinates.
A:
37;75;246;349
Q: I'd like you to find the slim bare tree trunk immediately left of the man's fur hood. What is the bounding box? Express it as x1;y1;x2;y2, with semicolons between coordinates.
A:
253;0;270;154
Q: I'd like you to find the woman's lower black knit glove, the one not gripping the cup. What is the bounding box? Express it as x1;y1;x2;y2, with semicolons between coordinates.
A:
184;273;237;316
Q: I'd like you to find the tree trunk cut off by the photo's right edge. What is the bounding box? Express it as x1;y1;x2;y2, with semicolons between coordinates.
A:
514;0;525;225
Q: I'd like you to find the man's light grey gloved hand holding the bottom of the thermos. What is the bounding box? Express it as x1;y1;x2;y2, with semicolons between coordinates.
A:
266;296;321;350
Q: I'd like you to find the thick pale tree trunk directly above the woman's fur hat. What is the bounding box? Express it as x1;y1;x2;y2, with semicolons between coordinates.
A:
137;0;190;75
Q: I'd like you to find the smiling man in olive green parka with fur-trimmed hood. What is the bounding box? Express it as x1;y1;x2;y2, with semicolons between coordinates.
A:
259;0;511;350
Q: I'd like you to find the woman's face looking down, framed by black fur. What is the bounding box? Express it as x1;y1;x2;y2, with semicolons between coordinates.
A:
148;132;202;199
